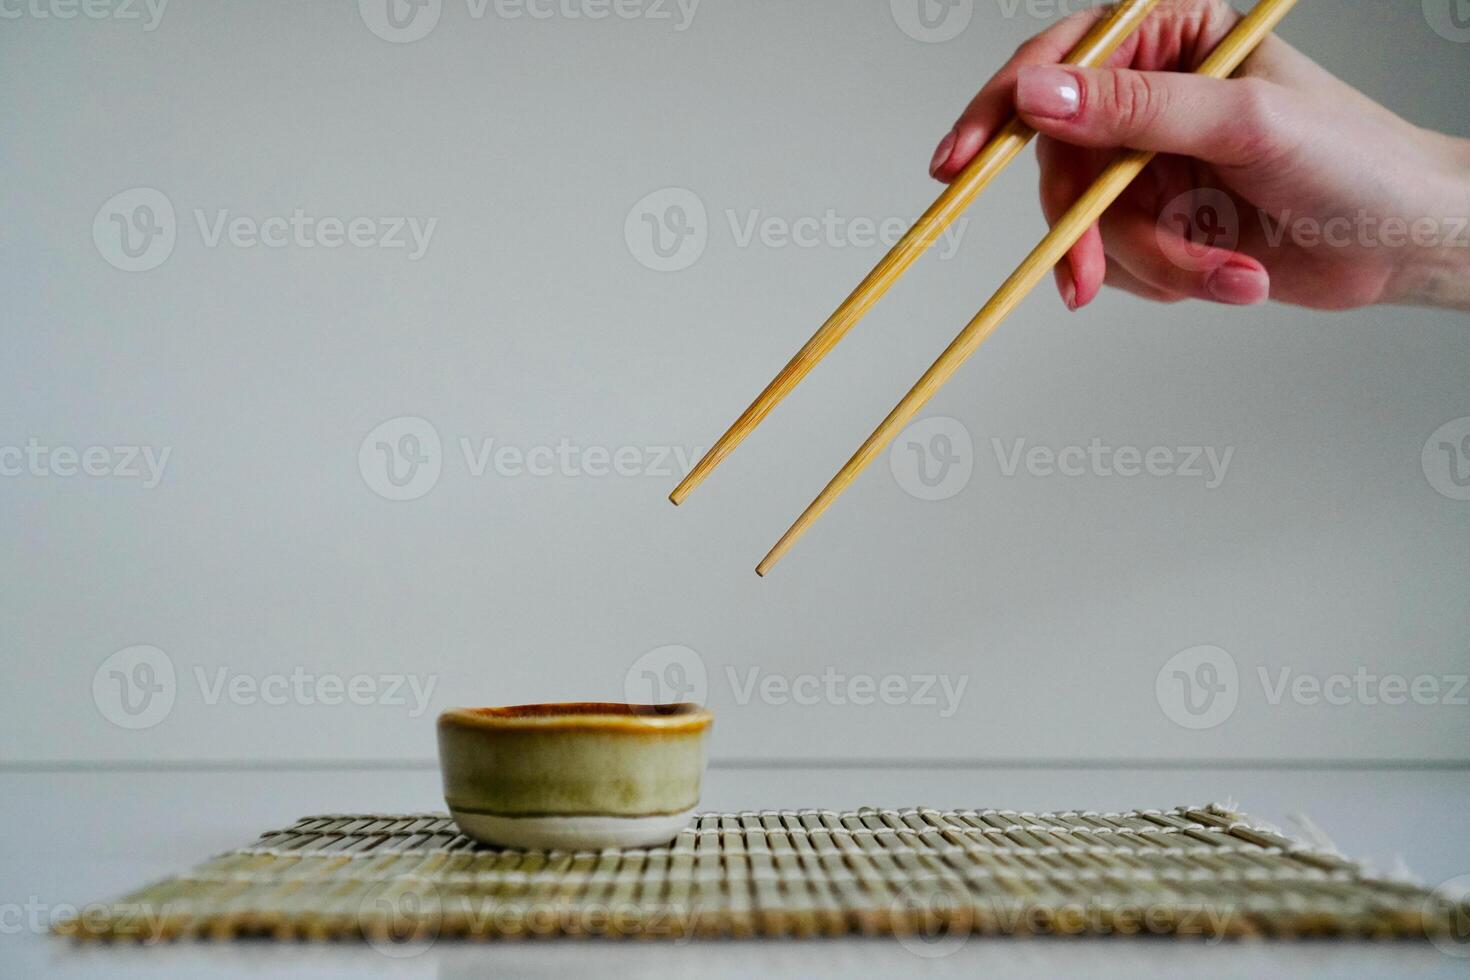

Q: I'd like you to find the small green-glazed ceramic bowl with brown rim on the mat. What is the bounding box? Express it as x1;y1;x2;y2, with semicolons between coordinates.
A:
440;702;714;851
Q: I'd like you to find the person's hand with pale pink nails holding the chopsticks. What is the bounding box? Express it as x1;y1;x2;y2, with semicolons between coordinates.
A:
931;0;1470;310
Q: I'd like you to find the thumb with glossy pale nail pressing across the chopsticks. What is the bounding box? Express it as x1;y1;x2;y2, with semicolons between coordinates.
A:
1016;65;1291;166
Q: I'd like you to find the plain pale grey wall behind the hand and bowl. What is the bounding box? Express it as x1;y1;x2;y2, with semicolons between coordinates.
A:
0;0;1470;764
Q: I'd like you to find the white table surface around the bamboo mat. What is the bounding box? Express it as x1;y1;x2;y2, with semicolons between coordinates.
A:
0;768;1470;980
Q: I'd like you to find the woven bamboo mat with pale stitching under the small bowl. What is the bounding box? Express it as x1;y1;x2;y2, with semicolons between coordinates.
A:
57;805;1466;943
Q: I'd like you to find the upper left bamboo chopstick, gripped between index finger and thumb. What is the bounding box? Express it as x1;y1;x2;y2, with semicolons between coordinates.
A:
669;0;1160;505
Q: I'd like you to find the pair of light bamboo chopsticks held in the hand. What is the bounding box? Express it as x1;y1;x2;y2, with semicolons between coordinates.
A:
669;0;1297;576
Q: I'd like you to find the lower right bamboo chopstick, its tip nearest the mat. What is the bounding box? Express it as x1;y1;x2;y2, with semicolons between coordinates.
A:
756;0;1297;576
